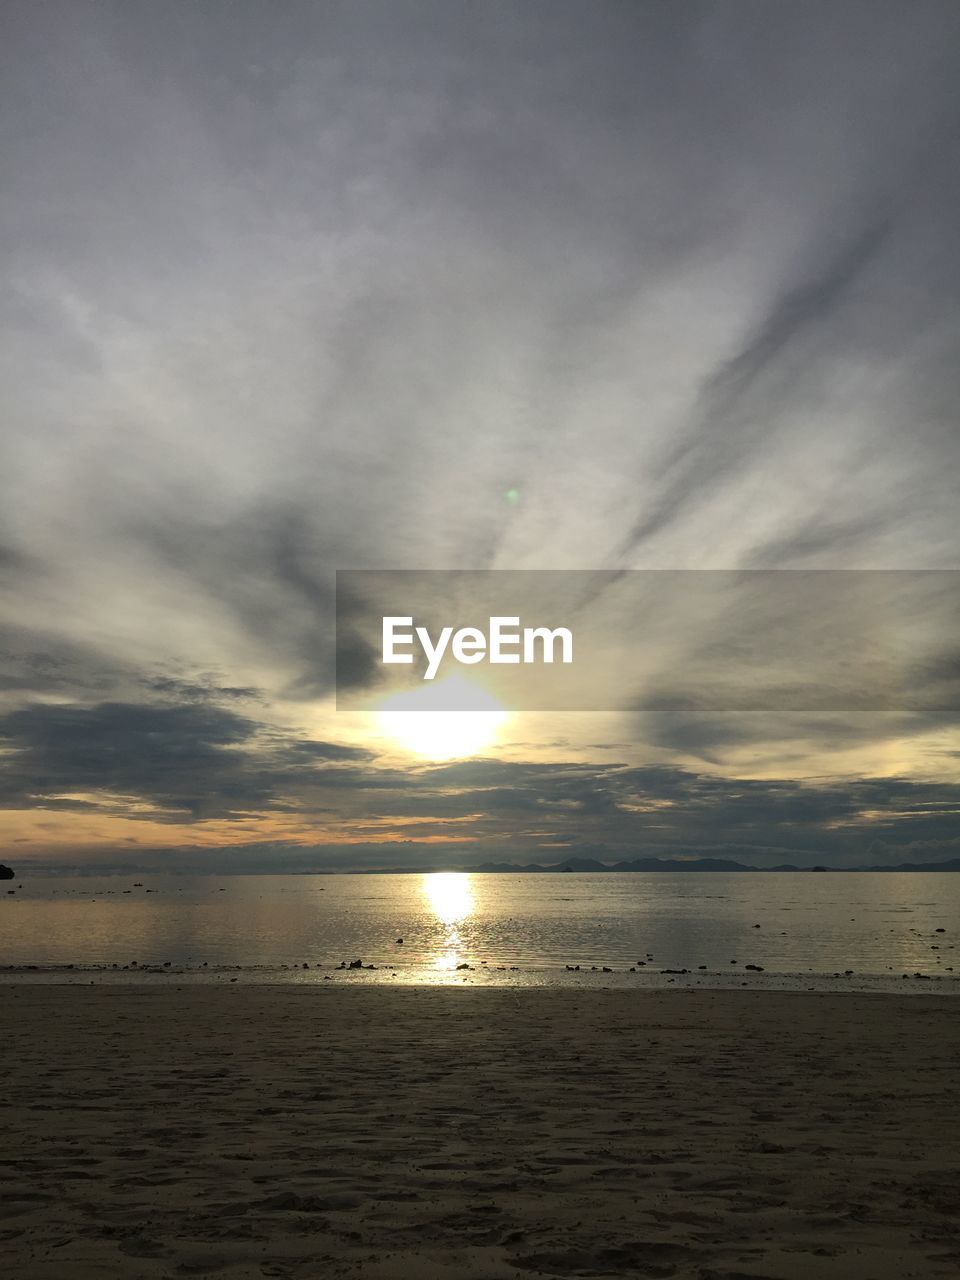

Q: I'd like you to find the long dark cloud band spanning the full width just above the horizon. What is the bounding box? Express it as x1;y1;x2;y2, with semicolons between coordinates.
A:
0;701;960;869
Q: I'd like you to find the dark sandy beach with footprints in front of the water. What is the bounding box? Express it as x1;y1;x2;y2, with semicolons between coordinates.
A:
0;979;960;1280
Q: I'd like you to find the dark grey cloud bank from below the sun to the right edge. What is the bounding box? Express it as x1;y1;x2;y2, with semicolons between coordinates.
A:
374;762;960;865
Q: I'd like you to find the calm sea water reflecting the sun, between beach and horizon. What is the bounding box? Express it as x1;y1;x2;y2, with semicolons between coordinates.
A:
0;873;960;992
